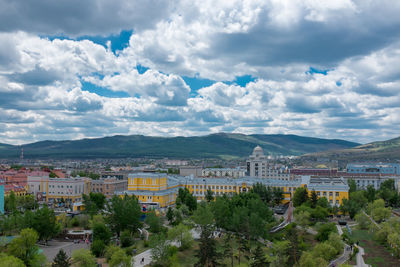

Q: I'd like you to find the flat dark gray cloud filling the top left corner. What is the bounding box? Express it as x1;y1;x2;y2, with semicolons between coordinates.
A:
0;0;171;36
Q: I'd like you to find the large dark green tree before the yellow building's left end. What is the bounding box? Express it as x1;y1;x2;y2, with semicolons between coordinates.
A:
107;195;141;236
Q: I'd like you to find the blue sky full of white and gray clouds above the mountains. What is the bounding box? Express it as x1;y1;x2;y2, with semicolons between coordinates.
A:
0;0;400;144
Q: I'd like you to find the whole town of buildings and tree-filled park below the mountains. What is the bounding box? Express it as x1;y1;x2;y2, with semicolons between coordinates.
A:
0;146;400;266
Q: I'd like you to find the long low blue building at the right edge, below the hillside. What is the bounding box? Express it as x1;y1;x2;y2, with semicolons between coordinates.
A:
346;163;400;175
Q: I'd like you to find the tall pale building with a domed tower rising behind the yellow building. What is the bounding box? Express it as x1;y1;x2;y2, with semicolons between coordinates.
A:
246;146;292;180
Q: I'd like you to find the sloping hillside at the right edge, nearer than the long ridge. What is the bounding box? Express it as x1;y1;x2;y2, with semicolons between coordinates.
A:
303;137;400;161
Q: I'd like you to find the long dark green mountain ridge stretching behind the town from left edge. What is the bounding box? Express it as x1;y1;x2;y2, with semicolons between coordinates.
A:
0;133;359;158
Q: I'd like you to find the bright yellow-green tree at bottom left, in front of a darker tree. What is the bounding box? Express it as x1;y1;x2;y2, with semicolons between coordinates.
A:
8;228;45;267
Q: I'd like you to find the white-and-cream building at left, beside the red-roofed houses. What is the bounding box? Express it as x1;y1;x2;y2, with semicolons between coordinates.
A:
28;176;91;203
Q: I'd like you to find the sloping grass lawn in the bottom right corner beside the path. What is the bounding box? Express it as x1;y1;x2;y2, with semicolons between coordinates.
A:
352;230;400;267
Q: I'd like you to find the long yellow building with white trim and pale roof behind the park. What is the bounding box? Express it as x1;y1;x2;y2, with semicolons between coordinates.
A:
118;173;349;208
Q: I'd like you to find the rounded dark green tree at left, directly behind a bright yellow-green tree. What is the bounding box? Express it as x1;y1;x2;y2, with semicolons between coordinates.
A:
32;206;61;242
